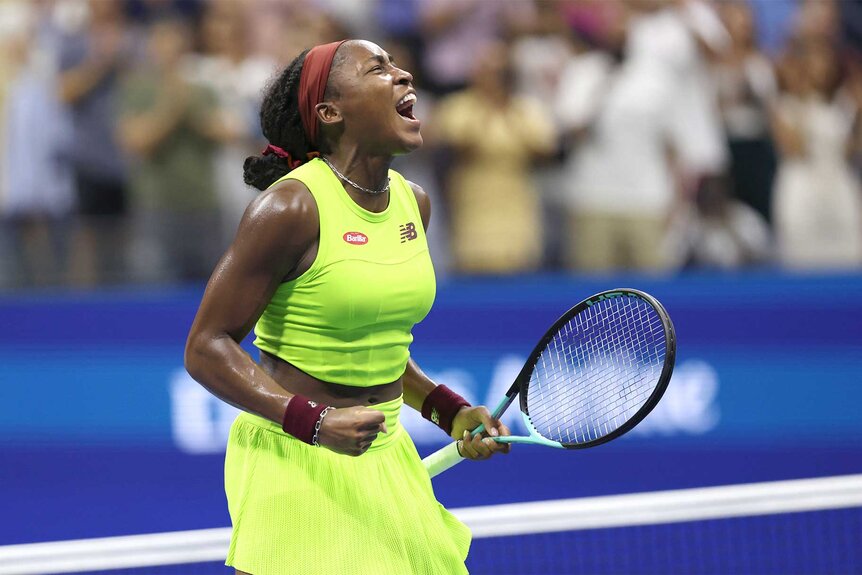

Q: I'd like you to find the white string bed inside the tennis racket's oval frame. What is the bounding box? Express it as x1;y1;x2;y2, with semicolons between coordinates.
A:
527;297;667;444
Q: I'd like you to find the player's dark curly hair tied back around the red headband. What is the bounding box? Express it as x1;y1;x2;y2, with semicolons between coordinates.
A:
243;50;345;190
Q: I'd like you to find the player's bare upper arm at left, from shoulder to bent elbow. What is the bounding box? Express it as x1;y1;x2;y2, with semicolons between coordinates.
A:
189;180;319;342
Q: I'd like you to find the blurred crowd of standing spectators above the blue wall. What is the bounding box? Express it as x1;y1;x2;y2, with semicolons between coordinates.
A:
0;0;862;288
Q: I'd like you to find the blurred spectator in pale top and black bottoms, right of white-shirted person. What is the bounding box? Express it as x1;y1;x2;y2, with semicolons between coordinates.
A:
715;1;778;222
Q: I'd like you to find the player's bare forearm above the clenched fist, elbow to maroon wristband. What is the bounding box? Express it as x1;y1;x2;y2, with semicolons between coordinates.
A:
185;335;293;425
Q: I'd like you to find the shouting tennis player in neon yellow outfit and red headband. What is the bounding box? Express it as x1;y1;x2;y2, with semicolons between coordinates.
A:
186;40;508;575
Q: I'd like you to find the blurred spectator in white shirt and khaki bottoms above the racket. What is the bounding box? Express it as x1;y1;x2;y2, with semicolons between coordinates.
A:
556;1;726;271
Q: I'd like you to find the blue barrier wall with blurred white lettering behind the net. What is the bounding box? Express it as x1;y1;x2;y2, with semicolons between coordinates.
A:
0;274;862;544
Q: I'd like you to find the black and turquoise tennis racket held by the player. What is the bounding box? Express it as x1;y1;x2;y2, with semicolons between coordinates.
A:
423;289;676;477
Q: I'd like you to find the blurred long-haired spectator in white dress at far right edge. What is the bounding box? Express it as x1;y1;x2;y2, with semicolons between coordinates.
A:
773;41;862;269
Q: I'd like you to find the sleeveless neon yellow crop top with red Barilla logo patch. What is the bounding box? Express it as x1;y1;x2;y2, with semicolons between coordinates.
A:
254;159;436;387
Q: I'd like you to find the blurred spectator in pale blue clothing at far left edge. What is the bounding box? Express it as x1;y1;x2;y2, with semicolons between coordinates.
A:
0;4;75;286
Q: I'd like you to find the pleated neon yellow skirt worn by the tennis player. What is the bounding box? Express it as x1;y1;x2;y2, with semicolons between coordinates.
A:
225;397;471;575
